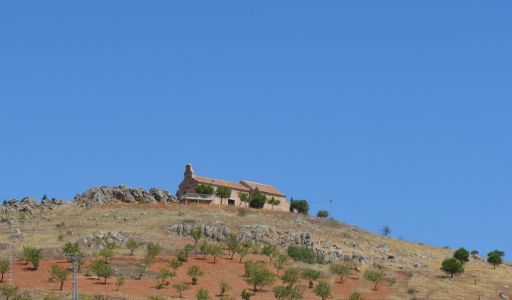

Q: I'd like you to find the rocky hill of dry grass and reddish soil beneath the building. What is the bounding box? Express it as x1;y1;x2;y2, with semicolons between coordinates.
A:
0;186;512;300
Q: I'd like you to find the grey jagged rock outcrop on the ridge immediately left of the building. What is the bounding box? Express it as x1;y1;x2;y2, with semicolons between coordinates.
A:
74;185;176;207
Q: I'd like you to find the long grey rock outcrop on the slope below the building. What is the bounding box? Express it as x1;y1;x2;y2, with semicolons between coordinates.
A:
168;223;344;262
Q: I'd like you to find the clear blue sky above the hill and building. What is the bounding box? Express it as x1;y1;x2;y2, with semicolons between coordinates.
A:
0;1;512;253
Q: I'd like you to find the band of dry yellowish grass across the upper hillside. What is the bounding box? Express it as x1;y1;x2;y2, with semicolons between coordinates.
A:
0;204;512;300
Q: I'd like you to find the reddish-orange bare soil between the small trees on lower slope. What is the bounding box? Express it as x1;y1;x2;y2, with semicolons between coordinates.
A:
14;256;389;300
